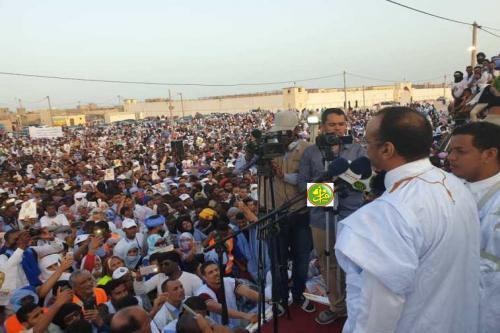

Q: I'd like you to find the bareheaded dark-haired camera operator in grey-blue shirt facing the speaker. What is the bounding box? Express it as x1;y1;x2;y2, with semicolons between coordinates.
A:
298;108;366;325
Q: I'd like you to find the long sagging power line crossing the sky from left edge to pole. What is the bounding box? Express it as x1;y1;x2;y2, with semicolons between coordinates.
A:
0;72;342;87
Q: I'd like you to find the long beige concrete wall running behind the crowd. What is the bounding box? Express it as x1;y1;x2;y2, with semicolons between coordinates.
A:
124;82;451;118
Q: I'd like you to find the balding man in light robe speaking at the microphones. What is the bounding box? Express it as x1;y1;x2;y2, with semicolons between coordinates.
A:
335;107;479;333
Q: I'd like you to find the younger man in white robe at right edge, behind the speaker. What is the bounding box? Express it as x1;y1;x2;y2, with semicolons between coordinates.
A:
448;122;500;333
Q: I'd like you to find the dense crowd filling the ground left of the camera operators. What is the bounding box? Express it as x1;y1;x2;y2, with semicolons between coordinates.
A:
0;111;334;333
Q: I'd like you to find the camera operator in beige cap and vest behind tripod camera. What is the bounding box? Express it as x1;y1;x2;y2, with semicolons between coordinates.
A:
259;111;314;312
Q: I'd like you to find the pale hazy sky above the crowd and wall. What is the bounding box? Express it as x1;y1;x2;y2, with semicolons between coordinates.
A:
0;0;500;109
